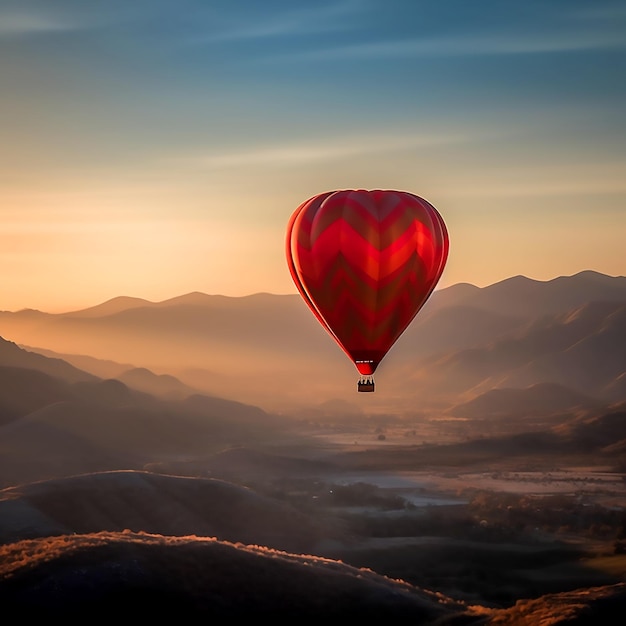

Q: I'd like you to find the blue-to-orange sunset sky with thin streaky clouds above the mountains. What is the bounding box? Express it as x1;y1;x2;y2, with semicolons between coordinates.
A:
0;0;626;312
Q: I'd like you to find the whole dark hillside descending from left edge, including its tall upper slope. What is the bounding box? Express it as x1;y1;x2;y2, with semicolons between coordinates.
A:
0;342;298;487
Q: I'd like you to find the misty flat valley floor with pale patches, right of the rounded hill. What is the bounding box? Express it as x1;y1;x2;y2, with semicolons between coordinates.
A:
241;416;626;606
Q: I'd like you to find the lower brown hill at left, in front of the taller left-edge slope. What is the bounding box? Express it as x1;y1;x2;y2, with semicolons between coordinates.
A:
0;392;289;488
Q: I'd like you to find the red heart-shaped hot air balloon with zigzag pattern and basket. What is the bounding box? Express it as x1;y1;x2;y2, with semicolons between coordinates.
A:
286;189;448;391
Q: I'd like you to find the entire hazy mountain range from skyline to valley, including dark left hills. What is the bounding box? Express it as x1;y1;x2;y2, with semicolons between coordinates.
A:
0;272;626;487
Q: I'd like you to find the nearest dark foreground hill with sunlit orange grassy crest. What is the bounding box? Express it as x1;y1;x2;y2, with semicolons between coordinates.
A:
0;532;626;626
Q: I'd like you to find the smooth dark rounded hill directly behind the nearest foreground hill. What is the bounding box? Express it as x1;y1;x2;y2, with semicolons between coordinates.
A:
0;471;331;552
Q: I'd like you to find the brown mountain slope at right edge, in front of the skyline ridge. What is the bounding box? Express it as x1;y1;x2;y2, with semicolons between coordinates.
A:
406;300;626;401
